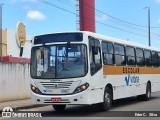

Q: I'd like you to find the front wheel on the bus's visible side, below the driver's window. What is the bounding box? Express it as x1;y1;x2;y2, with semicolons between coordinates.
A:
100;87;113;111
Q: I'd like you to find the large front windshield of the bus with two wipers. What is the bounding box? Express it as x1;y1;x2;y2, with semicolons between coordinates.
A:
31;43;87;79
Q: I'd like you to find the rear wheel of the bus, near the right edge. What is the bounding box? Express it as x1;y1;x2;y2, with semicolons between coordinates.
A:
137;83;151;101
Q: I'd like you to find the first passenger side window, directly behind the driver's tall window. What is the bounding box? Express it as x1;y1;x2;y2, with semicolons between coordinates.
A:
102;41;114;65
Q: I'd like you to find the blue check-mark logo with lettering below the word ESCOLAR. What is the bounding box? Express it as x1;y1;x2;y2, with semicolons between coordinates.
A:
125;74;139;86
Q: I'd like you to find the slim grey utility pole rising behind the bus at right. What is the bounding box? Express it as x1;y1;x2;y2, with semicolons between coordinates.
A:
144;7;151;46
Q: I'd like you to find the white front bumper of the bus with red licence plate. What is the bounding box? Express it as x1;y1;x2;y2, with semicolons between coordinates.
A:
32;90;93;105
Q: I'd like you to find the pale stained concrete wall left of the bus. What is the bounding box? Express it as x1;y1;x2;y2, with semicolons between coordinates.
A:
0;62;31;102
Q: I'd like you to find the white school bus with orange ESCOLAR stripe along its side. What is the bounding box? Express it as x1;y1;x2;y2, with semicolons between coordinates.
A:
31;31;160;111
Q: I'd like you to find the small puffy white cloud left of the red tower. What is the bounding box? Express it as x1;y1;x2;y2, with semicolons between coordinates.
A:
27;10;46;20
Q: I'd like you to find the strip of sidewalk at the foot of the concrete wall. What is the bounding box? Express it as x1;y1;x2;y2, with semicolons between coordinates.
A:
0;99;43;112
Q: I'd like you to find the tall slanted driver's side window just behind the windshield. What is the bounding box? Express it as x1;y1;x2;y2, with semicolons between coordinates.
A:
89;39;102;76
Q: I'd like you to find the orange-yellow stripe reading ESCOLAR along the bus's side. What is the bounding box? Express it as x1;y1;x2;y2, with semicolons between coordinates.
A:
103;65;160;75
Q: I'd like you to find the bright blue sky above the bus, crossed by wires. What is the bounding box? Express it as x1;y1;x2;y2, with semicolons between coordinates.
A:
0;0;160;48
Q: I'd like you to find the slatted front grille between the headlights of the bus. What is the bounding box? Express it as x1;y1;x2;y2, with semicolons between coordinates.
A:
41;81;73;89
